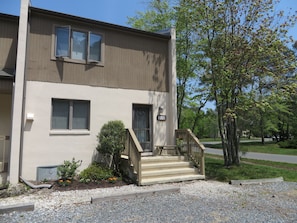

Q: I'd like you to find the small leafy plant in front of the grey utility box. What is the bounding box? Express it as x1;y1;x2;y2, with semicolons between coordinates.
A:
57;158;82;181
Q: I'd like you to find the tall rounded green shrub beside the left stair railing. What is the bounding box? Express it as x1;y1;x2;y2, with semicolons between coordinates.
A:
97;120;125;174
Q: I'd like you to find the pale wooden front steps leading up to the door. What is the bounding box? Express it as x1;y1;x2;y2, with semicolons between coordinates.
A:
139;156;205;185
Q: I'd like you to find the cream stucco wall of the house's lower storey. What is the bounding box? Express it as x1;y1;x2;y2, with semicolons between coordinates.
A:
20;81;175;180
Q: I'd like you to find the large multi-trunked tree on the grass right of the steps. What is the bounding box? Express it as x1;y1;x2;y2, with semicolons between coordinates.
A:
187;0;296;166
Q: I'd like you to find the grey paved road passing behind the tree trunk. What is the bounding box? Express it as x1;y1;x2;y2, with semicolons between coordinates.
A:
205;147;297;164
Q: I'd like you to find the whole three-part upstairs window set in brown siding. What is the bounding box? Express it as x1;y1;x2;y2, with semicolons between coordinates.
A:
54;26;104;64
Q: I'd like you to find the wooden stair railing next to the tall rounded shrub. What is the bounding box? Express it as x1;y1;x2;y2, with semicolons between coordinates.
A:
122;129;143;184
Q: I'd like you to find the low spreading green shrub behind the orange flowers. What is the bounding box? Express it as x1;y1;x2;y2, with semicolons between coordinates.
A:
79;164;113;183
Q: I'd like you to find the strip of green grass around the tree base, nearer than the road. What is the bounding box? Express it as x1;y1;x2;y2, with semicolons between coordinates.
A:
205;155;297;182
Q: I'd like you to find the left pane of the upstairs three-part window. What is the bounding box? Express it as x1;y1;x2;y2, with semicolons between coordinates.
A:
56;27;70;57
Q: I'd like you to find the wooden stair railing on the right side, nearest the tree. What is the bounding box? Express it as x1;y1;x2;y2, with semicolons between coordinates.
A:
175;129;205;175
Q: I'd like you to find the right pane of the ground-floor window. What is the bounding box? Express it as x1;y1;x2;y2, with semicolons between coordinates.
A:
72;101;90;129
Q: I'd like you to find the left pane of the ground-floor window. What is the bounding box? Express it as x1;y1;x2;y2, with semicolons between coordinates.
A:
52;100;69;129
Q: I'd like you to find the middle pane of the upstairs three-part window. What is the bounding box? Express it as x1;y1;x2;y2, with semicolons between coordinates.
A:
71;31;87;60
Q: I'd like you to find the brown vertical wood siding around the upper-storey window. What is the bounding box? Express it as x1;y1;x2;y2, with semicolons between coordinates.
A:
27;13;168;92
